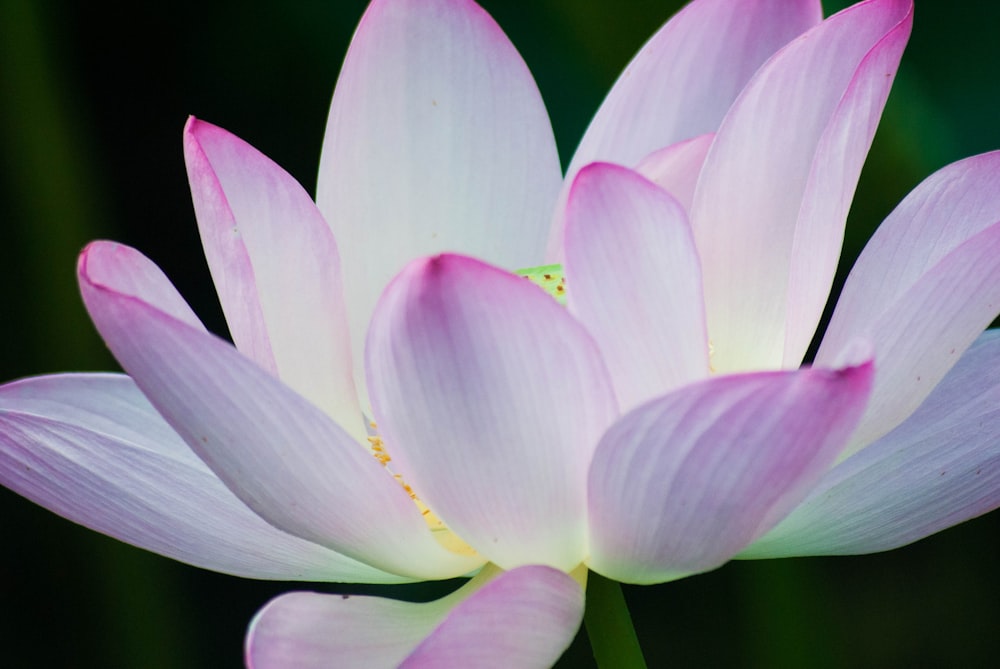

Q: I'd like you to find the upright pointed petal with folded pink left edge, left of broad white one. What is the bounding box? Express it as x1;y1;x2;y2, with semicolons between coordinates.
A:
184;117;366;439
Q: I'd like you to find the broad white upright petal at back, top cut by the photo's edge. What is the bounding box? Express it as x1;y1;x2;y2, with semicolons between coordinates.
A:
317;0;561;404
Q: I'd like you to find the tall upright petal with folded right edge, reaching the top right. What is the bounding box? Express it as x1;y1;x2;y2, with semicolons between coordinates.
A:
691;0;912;372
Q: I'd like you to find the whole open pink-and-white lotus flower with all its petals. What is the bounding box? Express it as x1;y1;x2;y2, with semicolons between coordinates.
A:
0;0;1000;667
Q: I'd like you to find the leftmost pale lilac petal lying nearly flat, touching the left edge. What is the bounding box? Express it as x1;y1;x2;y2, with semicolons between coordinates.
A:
0;374;404;583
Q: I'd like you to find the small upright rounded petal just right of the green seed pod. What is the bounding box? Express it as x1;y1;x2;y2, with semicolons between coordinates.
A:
566;163;709;411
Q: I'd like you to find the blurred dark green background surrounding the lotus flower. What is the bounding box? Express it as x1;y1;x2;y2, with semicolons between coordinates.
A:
0;0;1000;669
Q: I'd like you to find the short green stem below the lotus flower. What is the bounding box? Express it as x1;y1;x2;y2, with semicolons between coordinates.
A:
583;572;646;669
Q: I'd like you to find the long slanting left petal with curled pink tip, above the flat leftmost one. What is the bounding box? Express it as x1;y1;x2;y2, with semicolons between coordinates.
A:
79;243;476;578
